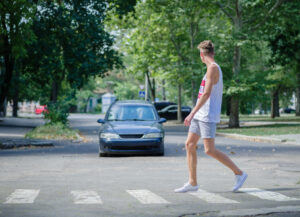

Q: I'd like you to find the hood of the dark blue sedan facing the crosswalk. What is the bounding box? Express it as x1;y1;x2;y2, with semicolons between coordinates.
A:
101;121;163;134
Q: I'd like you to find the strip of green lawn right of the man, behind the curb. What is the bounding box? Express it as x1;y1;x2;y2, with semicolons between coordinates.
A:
218;124;300;136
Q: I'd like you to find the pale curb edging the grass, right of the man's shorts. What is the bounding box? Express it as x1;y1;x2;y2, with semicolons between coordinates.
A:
216;133;286;143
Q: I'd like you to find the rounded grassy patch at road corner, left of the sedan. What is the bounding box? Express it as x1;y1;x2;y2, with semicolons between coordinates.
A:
25;123;79;140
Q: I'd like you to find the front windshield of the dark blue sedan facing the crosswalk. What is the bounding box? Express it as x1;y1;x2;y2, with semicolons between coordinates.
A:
108;105;156;121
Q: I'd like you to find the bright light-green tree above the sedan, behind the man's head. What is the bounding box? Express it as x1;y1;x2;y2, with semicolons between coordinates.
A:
107;0;209;120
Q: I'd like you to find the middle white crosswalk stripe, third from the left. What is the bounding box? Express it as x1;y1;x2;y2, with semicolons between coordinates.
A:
127;189;169;204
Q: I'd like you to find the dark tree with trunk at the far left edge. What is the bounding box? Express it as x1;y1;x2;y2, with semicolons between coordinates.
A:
0;0;36;116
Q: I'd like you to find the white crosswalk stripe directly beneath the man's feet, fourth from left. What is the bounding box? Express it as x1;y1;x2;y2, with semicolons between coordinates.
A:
190;189;239;203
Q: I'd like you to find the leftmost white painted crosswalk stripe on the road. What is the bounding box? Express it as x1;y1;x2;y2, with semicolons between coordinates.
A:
4;189;40;204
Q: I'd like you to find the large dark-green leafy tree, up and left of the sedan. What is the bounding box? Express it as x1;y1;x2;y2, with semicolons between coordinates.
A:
24;0;137;122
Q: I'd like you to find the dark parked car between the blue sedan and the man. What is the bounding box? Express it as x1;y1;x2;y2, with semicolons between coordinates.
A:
158;105;192;120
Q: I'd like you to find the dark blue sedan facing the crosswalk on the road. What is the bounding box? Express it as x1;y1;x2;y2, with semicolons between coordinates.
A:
98;100;166;156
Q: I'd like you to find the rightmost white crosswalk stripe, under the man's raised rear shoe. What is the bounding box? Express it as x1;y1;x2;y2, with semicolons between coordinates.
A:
239;188;300;201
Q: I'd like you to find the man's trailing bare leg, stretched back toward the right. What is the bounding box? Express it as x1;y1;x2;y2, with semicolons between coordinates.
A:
203;138;243;175
